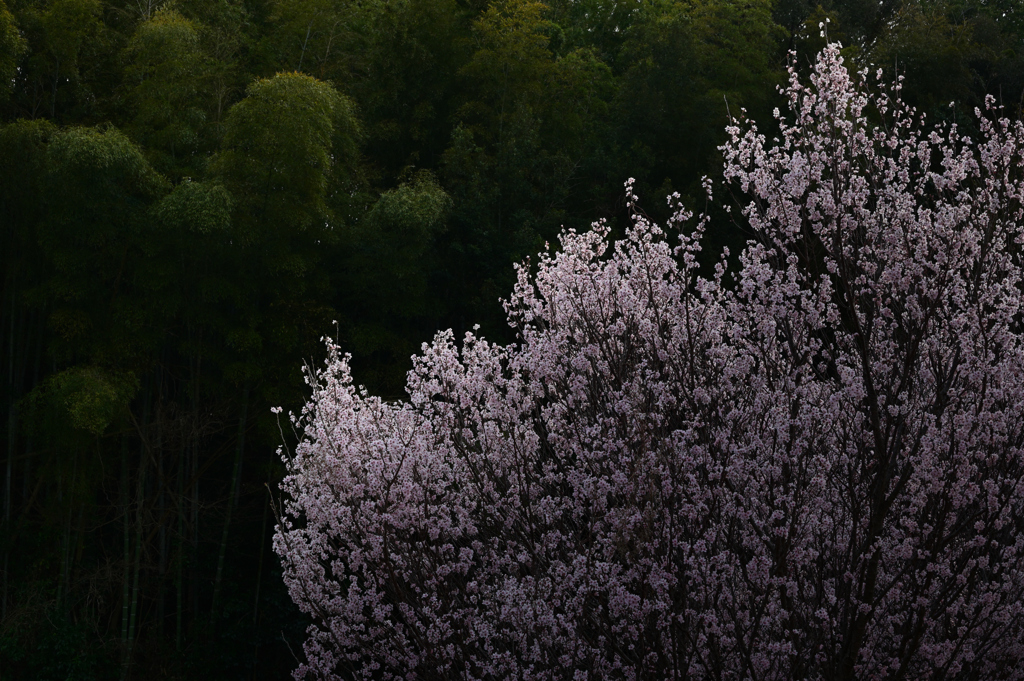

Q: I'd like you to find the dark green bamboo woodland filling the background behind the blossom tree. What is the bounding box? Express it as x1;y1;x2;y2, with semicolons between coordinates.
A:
0;0;1024;680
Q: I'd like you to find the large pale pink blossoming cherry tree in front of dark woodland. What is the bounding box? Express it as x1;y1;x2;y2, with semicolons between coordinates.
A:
274;45;1024;680
